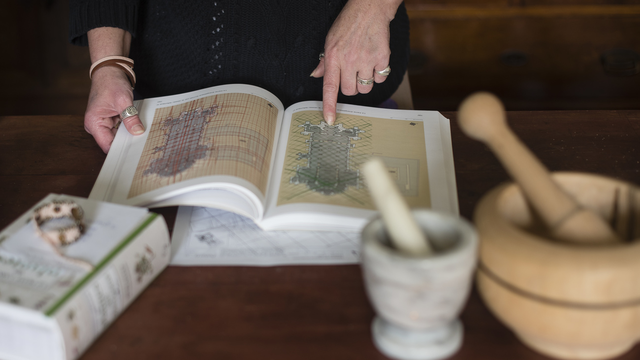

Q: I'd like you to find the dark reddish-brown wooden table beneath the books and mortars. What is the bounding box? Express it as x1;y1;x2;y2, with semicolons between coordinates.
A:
0;111;640;360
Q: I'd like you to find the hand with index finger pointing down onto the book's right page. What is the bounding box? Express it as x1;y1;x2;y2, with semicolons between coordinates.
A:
311;0;401;125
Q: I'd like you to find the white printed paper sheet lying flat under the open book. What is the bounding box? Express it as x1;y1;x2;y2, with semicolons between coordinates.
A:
171;206;360;266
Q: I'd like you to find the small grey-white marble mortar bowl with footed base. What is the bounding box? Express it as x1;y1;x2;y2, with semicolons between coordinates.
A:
362;209;478;360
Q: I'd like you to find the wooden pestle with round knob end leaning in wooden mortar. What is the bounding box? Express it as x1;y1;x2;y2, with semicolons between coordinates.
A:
458;92;621;243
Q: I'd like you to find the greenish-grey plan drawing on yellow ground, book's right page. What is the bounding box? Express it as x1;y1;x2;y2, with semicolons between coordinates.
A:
277;111;430;210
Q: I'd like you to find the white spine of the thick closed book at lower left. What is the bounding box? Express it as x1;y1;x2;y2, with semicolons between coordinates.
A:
47;214;171;360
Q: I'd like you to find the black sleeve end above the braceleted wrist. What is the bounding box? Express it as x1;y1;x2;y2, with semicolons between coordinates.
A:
69;0;139;46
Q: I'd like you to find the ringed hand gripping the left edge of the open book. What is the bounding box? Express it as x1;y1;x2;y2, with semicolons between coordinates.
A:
84;66;144;153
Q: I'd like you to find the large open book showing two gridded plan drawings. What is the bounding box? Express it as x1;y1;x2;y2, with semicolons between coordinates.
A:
90;85;458;231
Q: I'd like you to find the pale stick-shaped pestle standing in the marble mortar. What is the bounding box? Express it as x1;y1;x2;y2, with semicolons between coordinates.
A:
362;158;433;256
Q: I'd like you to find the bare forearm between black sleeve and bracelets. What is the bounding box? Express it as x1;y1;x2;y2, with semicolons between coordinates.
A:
87;27;131;63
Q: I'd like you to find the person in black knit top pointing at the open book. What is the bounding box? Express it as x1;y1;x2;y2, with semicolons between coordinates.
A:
69;0;409;152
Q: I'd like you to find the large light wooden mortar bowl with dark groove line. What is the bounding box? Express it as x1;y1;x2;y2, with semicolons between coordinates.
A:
474;173;640;359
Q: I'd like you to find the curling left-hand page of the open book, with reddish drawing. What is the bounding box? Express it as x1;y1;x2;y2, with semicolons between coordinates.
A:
90;85;283;219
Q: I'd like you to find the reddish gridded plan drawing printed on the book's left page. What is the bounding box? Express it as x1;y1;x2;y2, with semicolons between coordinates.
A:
128;93;278;198
